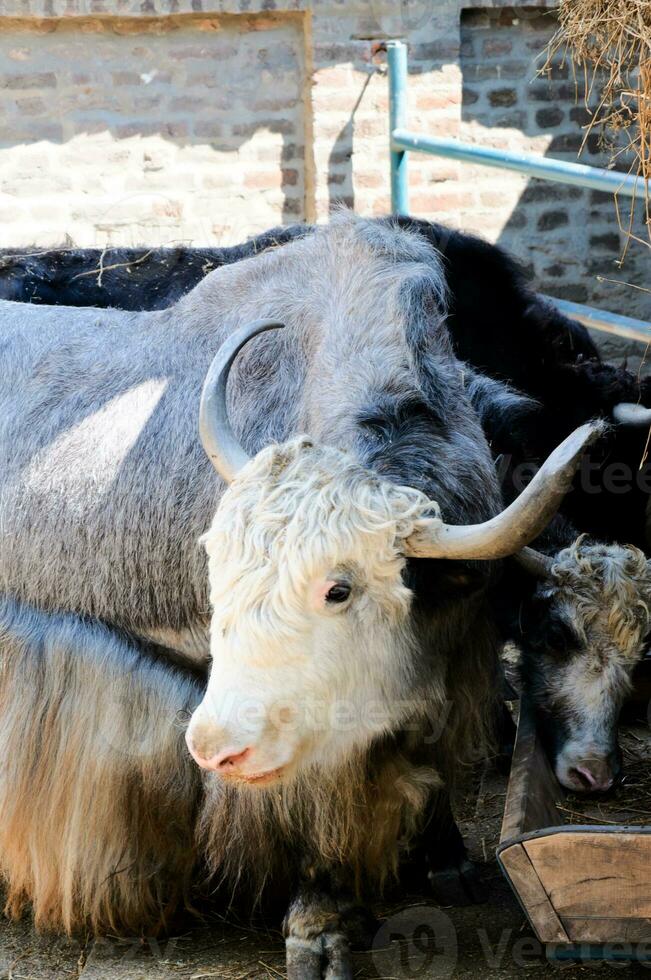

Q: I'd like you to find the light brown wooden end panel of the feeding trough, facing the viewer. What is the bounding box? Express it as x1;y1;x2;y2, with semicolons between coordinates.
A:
523;831;651;942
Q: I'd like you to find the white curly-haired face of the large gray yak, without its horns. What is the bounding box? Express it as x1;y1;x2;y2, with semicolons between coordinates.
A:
189;437;448;779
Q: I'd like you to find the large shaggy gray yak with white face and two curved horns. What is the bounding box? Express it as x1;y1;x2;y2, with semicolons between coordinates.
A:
0;216;599;980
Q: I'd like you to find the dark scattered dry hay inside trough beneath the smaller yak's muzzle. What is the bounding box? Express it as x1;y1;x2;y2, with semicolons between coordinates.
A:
556;724;651;827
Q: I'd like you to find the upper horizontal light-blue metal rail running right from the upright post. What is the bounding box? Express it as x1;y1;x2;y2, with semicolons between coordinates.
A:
391;126;651;198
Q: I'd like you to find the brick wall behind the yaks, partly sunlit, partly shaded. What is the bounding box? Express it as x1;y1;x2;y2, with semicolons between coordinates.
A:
0;0;651;364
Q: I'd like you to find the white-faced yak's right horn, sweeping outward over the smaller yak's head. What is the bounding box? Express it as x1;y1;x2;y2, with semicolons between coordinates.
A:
405;422;607;559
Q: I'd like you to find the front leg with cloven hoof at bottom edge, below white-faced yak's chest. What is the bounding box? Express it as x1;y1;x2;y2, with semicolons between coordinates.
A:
284;875;377;980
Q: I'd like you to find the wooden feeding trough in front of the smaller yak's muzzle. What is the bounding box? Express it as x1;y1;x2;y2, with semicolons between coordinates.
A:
497;665;651;960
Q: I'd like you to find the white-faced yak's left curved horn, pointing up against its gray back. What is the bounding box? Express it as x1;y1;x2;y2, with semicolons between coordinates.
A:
199;320;285;483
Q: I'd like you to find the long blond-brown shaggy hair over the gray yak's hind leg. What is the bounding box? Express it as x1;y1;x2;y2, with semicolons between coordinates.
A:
0;598;201;934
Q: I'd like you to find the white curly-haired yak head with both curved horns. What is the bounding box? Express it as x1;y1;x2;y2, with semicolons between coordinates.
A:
187;321;597;786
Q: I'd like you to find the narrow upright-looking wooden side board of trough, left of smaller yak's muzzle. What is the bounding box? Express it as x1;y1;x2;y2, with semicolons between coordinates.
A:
500;699;564;842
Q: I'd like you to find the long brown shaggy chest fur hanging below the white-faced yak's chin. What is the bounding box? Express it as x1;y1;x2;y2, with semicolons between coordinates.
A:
200;739;441;902
